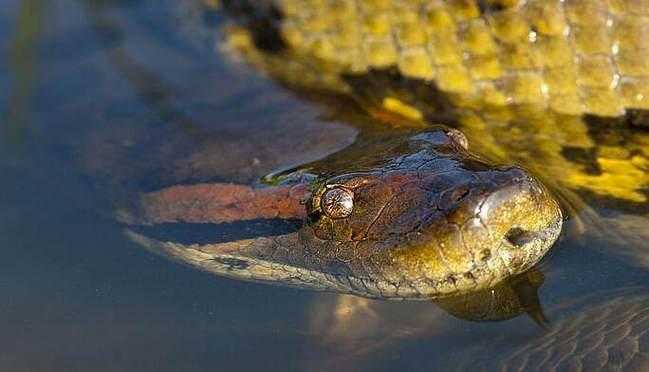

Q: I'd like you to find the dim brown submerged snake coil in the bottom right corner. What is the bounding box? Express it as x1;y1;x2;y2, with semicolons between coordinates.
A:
457;288;649;372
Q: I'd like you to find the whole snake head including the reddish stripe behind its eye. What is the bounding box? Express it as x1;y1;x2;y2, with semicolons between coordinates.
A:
126;128;562;299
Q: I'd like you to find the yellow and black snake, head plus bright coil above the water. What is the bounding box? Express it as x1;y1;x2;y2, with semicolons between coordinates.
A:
120;0;649;299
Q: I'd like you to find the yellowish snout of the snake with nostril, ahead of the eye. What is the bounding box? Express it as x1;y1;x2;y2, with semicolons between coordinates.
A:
397;167;562;295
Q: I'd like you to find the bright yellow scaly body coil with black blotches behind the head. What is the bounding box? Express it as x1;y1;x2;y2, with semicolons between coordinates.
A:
216;0;649;204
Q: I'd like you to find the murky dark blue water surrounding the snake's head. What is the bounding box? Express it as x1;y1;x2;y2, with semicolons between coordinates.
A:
0;0;649;371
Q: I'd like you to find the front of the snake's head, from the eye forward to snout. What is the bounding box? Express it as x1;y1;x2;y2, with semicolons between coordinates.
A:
301;129;562;297
